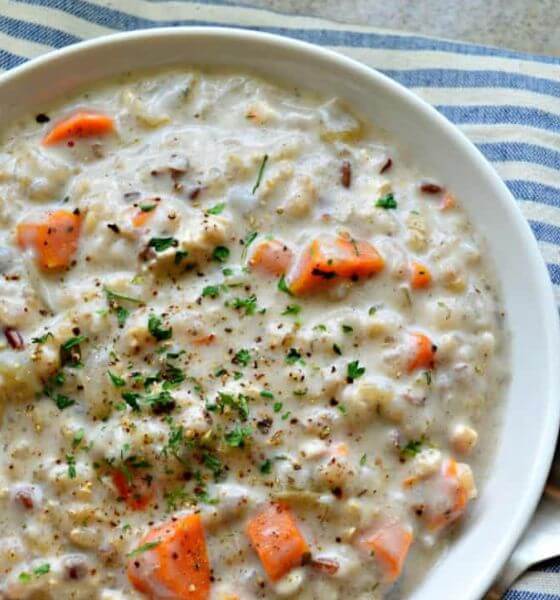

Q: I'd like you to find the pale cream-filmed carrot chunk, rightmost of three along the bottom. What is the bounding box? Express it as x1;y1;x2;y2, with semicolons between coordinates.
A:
359;521;412;583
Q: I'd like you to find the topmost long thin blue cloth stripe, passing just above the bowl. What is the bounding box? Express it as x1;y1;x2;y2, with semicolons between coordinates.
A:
10;0;560;65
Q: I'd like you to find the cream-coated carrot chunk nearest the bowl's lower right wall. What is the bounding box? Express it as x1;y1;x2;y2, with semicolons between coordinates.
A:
422;458;476;531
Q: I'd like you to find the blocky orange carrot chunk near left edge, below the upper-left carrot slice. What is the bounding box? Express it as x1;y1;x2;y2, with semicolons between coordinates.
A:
17;210;80;269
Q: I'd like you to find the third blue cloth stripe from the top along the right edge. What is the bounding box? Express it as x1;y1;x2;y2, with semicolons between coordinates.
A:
436;105;560;133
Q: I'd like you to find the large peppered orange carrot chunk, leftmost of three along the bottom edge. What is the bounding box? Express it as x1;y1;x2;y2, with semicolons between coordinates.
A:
127;514;211;600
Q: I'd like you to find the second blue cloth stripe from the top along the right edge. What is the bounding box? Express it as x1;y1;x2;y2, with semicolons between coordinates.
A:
380;65;560;98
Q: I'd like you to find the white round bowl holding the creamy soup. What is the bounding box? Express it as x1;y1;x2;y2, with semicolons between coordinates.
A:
0;28;560;600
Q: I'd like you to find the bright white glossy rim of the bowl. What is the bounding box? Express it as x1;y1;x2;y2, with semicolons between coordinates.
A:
0;26;560;600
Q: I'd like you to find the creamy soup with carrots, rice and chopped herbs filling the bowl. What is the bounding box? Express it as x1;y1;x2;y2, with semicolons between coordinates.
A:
0;69;508;600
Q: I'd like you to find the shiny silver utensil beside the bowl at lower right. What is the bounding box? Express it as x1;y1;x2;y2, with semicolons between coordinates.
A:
485;446;560;600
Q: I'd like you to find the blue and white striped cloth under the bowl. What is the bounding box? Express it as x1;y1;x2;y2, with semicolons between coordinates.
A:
0;0;560;600
